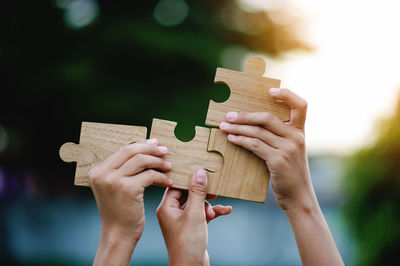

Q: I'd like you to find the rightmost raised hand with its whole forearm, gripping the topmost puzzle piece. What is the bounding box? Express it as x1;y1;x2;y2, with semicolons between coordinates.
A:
220;89;344;265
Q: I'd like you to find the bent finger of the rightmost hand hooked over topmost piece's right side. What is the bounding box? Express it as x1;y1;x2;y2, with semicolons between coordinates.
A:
269;88;307;129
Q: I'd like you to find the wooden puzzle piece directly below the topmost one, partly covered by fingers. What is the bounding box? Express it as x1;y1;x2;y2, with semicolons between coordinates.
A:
208;128;269;202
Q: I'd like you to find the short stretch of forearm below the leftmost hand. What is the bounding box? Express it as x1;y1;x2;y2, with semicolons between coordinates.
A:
93;227;137;266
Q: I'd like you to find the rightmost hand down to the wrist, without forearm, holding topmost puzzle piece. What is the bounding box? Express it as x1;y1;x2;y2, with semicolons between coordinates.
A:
220;89;315;210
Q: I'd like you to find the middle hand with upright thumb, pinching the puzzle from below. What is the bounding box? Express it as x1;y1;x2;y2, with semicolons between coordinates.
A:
157;169;232;265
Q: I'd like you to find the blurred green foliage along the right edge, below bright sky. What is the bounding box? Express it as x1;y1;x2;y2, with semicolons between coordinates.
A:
344;93;400;265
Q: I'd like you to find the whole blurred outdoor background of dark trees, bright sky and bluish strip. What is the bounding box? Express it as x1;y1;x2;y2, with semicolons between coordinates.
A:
0;0;400;265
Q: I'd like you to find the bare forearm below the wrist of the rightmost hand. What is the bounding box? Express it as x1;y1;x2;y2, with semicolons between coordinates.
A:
285;195;344;266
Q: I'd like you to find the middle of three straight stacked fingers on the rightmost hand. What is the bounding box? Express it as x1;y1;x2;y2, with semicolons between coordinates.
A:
219;122;283;148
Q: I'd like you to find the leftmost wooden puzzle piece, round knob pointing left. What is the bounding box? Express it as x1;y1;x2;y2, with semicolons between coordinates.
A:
60;122;147;186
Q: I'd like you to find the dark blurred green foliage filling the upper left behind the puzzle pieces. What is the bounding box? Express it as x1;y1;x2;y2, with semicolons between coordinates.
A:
0;0;309;195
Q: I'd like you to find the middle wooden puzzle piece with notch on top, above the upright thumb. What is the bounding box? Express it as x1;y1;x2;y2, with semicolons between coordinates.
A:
150;119;223;189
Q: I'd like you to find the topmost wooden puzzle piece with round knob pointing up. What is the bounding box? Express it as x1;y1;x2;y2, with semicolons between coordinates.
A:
206;56;290;126
